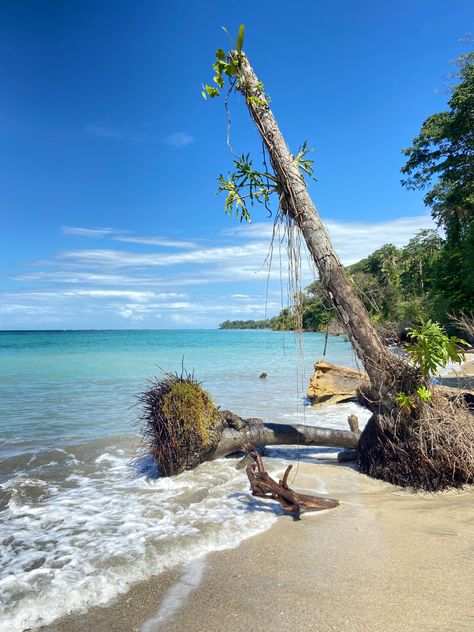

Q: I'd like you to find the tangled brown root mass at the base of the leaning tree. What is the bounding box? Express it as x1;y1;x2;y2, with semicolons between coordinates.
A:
357;394;474;491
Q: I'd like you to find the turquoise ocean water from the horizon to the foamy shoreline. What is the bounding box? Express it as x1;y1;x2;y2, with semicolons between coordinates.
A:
0;330;367;632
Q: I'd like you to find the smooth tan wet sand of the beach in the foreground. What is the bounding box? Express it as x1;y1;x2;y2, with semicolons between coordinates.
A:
42;458;474;632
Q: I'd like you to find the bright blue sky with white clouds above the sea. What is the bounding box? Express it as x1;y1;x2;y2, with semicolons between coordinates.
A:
0;0;474;329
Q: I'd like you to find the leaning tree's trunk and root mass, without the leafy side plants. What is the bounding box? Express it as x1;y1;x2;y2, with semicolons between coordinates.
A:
213;51;474;491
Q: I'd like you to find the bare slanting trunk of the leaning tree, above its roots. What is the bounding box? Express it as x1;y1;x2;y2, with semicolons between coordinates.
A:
235;51;398;391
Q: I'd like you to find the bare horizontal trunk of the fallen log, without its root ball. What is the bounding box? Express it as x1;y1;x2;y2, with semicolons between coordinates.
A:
206;423;360;461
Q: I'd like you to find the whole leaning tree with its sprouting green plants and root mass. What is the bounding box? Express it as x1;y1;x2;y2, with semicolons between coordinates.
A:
199;25;474;489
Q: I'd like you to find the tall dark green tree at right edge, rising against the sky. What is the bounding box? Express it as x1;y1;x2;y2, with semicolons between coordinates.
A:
402;52;474;318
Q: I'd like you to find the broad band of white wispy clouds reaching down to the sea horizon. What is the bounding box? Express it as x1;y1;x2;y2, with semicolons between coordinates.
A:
4;215;440;328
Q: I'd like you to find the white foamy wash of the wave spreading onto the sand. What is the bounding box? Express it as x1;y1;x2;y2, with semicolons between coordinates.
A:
0;440;288;632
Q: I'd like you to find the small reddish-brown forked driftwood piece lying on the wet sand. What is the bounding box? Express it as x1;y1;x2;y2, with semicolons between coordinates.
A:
242;443;339;517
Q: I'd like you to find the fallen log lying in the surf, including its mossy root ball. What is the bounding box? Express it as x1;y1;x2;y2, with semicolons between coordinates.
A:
140;373;360;476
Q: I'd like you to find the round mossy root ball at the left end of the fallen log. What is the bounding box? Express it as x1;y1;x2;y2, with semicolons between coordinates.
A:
139;372;222;476
